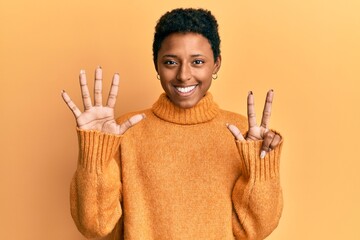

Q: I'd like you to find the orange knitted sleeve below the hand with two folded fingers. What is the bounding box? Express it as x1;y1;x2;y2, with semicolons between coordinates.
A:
232;136;283;240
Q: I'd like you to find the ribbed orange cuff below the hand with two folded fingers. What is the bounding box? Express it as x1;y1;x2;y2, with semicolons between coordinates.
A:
236;140;283;181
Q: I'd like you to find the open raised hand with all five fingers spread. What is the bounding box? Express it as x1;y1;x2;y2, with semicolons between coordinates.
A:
61;67;145;135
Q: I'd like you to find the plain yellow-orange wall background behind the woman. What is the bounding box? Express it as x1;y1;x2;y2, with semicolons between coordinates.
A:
0;0;360;240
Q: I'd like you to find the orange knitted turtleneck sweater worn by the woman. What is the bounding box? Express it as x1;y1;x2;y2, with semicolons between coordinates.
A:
70;93;283;240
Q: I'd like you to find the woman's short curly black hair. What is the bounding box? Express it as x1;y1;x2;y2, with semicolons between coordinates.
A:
153;8;220;66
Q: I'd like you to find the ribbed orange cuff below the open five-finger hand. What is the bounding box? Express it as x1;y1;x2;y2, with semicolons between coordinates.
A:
77;129;122;173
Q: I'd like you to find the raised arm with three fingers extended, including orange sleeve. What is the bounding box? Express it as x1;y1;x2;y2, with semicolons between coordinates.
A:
228;90;283;240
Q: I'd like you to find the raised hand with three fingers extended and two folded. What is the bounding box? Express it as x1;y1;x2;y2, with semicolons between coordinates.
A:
228;90;281;158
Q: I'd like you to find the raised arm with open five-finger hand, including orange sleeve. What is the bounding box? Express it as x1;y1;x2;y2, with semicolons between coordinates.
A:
62;67;145;237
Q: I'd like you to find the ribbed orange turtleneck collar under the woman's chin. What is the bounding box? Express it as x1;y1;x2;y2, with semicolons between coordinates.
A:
152;92;219;125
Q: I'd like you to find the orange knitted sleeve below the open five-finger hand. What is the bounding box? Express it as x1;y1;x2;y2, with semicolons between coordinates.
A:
70;129;122;238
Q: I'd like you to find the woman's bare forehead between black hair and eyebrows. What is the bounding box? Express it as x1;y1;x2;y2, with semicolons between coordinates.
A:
159;33;212;55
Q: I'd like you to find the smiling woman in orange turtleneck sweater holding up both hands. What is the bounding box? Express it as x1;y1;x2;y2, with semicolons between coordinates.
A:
62;9;282;239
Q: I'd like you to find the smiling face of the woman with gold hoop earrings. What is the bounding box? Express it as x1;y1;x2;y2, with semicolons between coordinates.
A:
157;33;221;108
